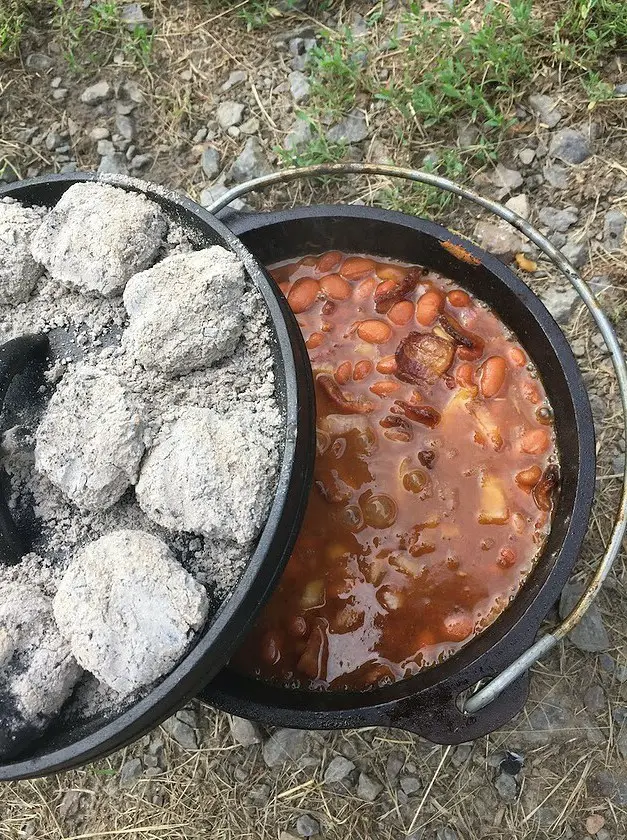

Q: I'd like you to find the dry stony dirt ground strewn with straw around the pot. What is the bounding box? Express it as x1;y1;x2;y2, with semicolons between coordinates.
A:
0;0;627;840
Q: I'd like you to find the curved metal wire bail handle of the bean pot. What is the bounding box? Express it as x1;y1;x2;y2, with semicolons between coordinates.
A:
207;163;627;714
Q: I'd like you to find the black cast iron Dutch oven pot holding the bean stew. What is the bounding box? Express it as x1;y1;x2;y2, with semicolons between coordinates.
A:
201;206;595;744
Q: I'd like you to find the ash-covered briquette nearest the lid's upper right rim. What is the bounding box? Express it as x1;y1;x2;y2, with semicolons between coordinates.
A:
124;245;245;376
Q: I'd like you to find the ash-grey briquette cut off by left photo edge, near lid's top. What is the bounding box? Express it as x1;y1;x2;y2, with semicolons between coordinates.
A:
0;199;45;306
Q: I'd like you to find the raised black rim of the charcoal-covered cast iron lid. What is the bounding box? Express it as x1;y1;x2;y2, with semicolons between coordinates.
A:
0;174;315;781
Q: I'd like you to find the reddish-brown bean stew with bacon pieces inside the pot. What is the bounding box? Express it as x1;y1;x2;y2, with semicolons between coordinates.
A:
234;252;559;690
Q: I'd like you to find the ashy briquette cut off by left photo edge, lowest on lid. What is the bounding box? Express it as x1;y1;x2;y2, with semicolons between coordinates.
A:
0;581;81;758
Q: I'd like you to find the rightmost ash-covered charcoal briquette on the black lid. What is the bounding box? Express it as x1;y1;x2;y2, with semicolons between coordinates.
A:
136;405;278;545
